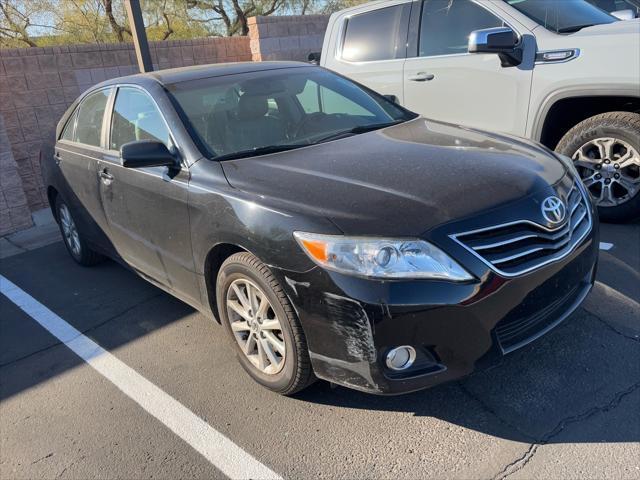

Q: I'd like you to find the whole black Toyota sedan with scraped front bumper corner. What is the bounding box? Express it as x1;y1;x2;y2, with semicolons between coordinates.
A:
44;62;598;394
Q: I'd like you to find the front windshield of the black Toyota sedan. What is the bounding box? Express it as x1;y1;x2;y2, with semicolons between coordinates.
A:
167;67;416;159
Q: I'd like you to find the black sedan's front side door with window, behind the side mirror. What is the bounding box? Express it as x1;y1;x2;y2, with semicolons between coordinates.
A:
98;86;200;301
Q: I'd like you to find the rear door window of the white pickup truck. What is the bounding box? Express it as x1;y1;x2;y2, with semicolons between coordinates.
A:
342;4;410;62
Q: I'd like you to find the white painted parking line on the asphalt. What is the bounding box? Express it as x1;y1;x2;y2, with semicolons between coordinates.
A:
0;275;281;479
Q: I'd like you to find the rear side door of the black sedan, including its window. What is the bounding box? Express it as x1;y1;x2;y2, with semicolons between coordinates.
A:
54;87;114;248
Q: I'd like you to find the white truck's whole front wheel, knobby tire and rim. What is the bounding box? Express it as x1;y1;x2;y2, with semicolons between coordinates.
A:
556;112;640;222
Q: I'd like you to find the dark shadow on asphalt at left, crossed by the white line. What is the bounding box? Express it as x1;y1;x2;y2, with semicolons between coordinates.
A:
0;242;195;401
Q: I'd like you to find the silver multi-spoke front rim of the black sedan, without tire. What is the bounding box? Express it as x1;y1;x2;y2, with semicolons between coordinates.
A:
226;278;286;375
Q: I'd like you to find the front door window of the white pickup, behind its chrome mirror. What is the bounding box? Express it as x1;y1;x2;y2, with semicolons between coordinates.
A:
419;0;504;57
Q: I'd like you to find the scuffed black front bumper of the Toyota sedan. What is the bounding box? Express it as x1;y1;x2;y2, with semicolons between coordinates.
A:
274;222;598;394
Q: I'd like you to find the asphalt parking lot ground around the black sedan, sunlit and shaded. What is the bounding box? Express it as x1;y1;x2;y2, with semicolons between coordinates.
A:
0;220;640;479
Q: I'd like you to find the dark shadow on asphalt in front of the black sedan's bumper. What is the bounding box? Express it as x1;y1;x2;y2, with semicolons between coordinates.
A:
296;302;640;443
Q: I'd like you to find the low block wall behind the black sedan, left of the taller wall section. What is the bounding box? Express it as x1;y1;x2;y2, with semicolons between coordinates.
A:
0;37;252;236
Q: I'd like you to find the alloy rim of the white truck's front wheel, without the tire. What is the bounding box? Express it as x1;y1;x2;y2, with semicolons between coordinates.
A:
573;137;640;207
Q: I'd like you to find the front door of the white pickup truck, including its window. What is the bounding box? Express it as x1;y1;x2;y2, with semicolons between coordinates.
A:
404;0;535;135
